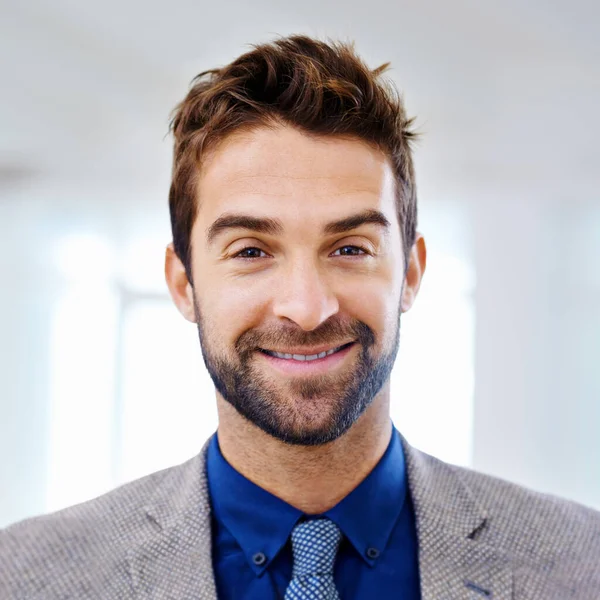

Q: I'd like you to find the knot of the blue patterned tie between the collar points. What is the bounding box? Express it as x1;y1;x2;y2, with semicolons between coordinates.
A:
292;518;342;577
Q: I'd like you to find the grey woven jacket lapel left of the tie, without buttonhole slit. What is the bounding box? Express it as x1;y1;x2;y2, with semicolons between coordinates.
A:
128;440;217;600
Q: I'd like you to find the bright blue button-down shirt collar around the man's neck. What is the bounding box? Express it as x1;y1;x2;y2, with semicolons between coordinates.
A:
207;427;407;575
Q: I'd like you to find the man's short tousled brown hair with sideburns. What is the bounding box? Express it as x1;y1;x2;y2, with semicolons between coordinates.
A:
169;35;417;282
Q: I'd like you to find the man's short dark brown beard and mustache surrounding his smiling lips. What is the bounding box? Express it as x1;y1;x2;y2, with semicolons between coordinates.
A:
194;297;401;446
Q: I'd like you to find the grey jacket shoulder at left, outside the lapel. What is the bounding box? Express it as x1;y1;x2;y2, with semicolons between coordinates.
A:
0;459;202;598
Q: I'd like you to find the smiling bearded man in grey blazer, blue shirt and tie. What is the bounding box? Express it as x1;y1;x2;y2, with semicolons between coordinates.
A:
0;36;600;600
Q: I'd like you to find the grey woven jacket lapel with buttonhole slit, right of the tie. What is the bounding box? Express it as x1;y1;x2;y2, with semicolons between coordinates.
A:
402;439;513;600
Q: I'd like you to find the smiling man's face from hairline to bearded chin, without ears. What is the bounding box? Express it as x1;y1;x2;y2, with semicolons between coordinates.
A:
191;126;404;445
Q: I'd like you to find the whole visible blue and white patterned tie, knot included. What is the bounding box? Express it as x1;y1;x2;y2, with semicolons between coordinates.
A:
285;518;342;600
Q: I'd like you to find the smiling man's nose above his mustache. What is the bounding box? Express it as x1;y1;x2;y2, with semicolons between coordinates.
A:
273;263;339;331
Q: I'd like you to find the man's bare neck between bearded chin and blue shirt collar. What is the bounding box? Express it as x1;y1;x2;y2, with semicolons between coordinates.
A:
217;390;392;514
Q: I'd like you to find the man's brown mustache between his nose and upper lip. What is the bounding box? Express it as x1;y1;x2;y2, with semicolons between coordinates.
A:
235;320;375;356
